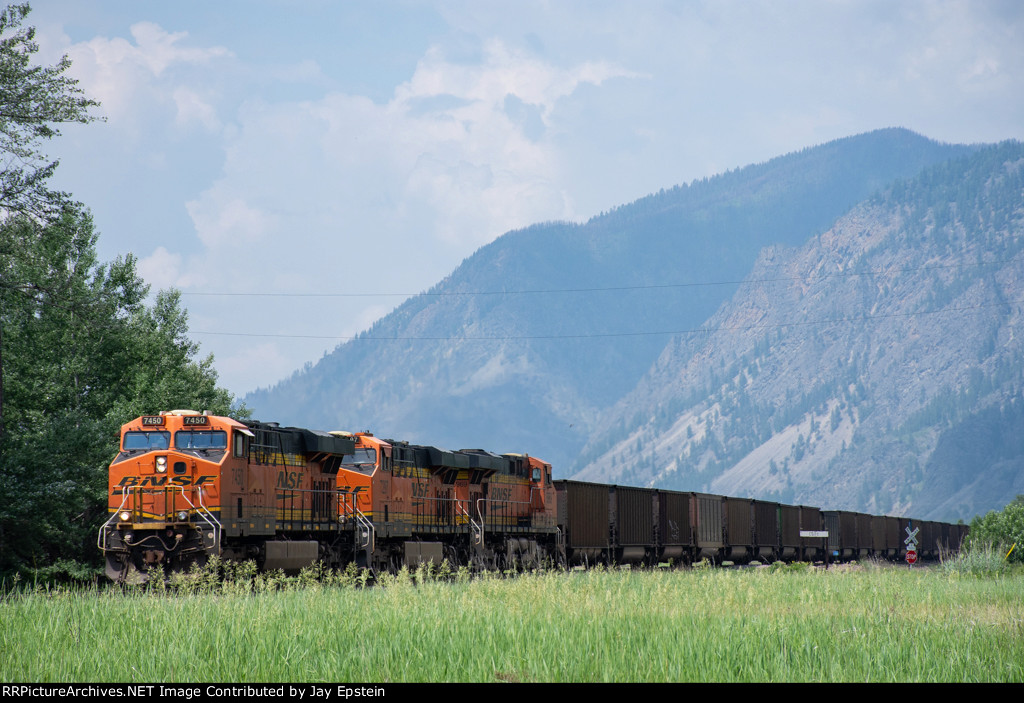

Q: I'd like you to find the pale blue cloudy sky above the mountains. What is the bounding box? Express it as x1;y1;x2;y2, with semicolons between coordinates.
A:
27;0;1024;395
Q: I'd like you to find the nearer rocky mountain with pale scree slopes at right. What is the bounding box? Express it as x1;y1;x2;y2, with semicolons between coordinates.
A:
575;142;1024;520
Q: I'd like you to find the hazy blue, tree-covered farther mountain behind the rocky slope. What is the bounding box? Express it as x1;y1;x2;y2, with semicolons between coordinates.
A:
245;129;973;476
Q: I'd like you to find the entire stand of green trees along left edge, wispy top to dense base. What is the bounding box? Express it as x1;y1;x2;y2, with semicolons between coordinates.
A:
0;4;239;573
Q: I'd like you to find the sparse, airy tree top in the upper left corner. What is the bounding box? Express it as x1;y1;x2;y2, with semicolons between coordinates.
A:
0;3;99;217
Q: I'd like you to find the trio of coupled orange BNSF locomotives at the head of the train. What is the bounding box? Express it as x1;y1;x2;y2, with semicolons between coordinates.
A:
98;410;563;581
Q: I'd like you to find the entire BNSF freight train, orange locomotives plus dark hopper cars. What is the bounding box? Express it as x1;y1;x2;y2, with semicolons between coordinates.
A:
97;410;966;581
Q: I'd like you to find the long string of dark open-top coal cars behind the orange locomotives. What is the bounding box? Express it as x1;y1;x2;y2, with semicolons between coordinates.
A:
555;480;967;565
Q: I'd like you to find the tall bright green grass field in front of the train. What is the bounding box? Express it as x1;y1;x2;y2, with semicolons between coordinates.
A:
0;566;1024;683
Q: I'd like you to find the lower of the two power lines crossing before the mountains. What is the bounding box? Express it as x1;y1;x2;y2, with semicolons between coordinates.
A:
188;300;1024;342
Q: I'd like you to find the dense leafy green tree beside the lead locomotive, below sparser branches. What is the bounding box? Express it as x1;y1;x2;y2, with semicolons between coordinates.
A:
0;208;244;571
